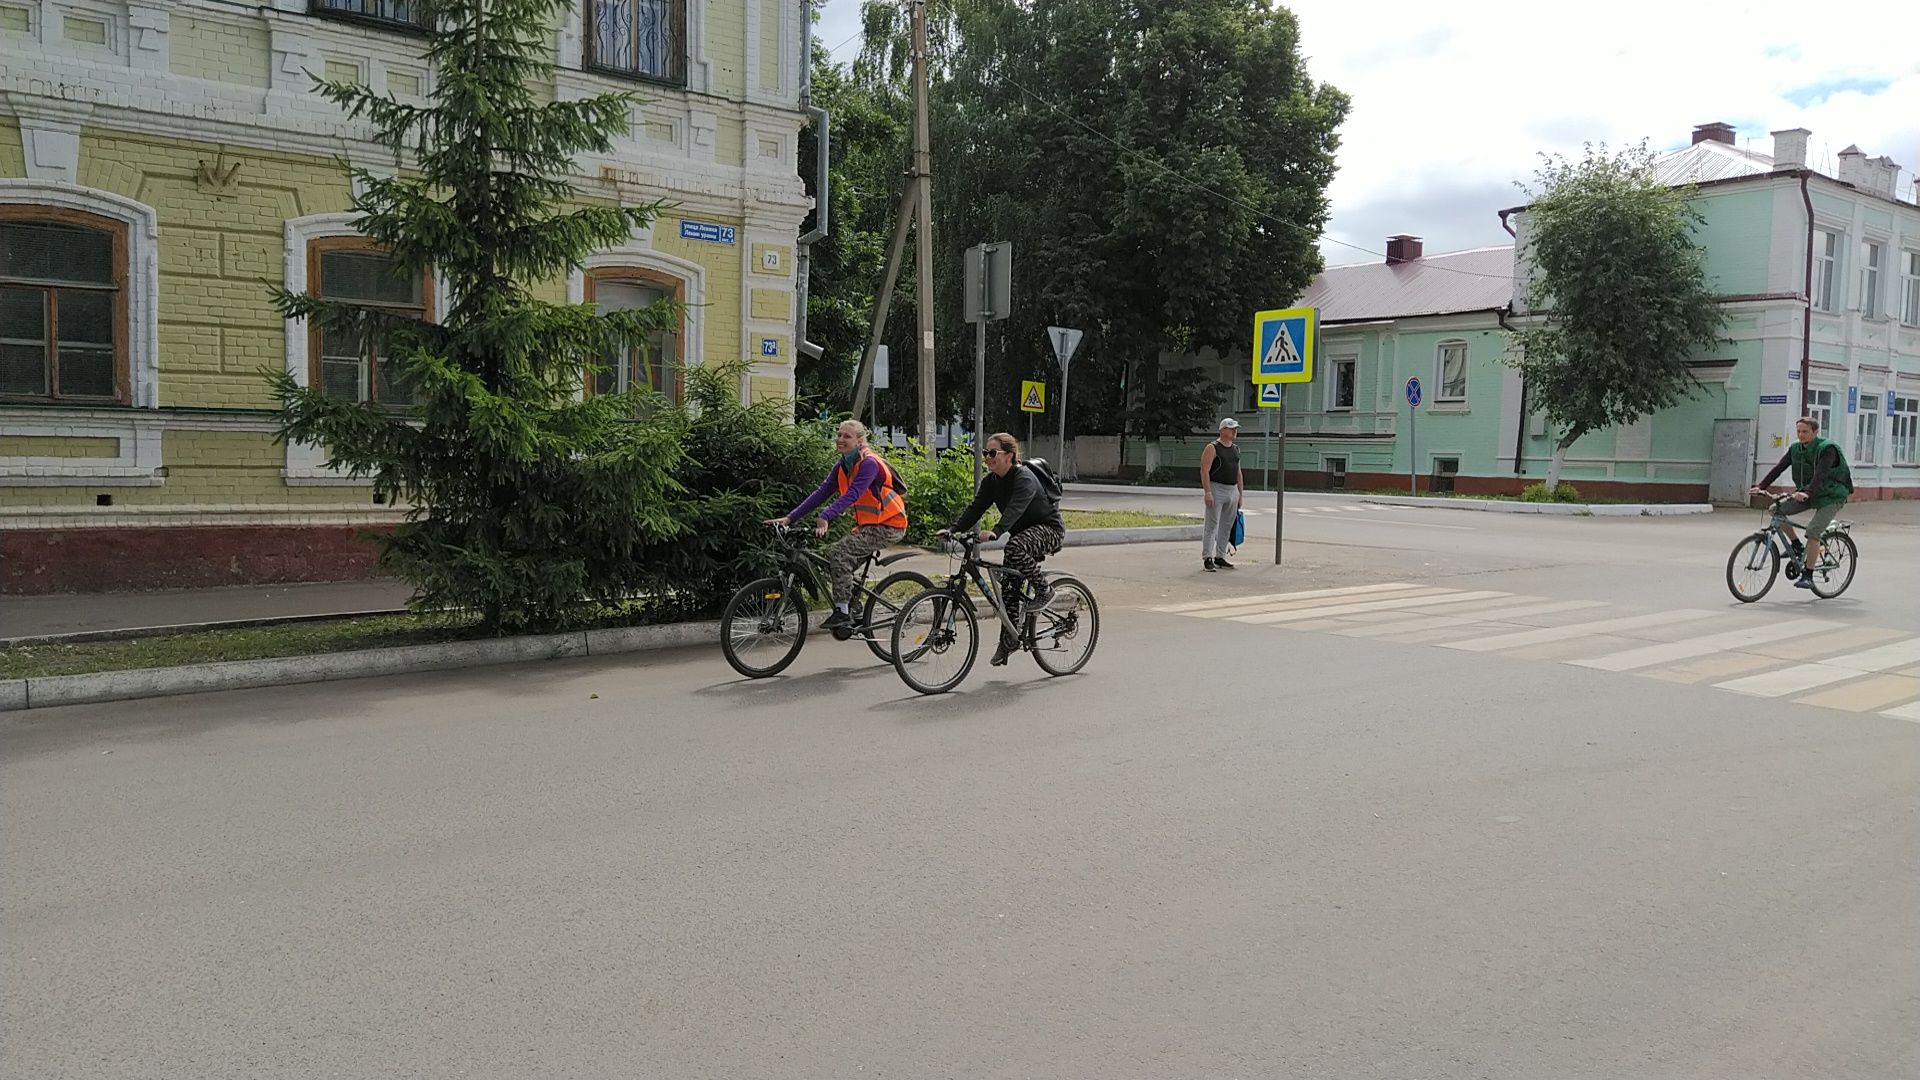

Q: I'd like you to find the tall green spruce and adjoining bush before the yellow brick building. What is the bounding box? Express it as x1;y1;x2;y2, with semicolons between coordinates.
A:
273;0;824;630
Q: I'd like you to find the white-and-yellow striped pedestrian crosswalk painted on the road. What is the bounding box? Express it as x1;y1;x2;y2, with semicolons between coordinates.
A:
1152;582;1920;723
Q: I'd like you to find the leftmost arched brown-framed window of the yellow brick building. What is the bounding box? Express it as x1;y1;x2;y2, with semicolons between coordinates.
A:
0;204;131;405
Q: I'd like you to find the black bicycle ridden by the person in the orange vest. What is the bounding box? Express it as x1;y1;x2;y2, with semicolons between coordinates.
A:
720;525;933;678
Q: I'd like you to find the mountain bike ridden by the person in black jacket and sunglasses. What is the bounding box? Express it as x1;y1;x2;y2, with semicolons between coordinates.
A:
893;534;1100;694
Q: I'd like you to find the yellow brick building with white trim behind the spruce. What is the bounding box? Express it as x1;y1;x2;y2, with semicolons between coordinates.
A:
0;0;810;592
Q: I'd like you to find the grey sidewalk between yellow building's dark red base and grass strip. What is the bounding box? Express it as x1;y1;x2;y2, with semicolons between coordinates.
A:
0;580;409;638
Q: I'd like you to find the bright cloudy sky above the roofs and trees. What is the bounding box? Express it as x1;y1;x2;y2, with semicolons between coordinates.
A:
820;0;1920;265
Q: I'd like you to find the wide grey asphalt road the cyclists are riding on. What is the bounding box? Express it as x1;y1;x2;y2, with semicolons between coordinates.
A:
11;500;1920;1080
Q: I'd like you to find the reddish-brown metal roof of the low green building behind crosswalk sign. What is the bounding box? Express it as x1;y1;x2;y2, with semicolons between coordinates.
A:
1298;244;1513;323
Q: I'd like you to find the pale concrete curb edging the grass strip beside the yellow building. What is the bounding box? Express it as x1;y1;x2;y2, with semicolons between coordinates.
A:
0;623;720;713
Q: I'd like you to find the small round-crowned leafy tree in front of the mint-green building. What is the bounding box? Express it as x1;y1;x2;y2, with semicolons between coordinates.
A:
1511;144;1726;492
